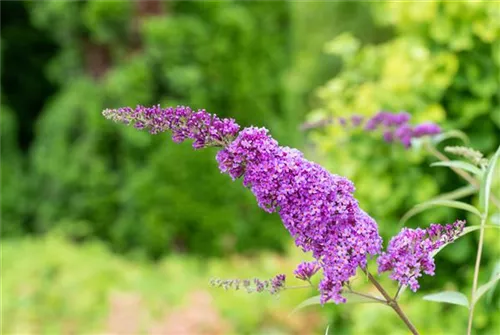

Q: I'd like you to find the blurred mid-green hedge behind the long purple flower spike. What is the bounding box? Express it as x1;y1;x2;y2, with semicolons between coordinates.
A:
2;1;298;257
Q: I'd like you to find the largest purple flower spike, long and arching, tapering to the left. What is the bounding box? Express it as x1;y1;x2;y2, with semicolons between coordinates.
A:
103;106;382;303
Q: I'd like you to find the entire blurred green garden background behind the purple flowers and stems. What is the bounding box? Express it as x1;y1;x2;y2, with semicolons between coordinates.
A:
0;0;500;335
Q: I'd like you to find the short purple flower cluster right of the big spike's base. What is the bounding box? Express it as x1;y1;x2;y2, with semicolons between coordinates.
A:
377;220;465;292
